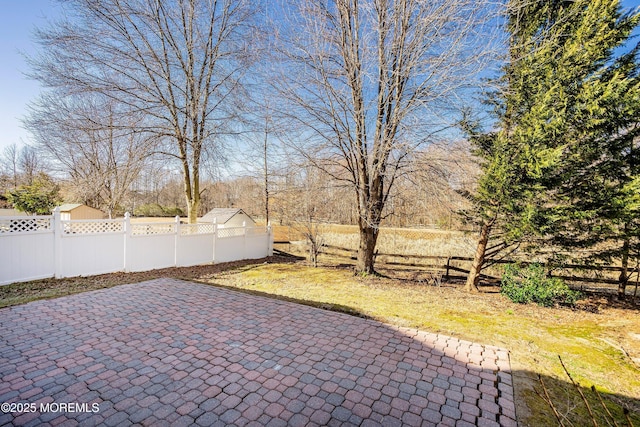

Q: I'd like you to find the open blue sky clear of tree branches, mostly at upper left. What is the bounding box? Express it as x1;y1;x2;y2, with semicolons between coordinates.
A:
0;0;640;152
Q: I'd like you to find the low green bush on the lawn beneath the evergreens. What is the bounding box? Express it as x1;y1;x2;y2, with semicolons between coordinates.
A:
500;264;580;307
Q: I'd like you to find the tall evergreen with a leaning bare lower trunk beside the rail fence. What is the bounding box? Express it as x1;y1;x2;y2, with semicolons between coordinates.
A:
467;0;639;290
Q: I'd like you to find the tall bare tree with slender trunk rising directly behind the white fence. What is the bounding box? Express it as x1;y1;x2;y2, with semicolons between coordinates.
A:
30;0;250;222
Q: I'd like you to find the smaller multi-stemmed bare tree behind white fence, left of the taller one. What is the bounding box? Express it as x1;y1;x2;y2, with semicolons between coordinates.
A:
25;95;152;218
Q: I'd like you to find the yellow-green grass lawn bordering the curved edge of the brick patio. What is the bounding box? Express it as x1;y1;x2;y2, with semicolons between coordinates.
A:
0;257;640;426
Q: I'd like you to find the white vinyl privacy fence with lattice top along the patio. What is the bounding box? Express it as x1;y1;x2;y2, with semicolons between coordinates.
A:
0;209;273;285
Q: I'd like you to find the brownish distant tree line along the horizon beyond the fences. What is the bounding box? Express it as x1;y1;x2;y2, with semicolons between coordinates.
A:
0;140;470;229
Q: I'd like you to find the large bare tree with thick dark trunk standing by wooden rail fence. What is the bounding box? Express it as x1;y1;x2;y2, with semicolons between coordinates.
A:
275;0;500;273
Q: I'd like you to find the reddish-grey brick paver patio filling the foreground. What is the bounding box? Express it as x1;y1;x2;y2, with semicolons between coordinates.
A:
0;279;516;426
